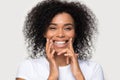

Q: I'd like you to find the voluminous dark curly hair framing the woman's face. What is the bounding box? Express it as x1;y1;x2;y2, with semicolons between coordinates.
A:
23;0;97;60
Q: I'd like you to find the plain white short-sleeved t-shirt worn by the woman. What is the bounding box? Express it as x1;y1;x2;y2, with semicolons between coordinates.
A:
16;56;104;80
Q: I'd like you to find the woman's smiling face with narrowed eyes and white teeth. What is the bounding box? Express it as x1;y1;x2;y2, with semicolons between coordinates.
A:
45;13;75;52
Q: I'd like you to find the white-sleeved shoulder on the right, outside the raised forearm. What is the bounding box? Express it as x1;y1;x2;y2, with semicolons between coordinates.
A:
79;60;104;80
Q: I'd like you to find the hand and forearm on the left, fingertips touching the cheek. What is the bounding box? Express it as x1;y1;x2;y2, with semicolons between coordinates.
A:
46;39;58;80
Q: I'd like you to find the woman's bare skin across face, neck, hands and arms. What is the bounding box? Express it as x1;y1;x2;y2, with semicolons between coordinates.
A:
16;12;85;80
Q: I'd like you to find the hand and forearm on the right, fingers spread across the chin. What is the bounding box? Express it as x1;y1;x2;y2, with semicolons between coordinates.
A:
58;39;84;80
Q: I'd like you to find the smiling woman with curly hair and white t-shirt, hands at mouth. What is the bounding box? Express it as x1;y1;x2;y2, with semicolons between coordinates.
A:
16;0;104;80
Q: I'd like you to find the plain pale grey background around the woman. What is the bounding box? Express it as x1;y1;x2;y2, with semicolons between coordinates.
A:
0;0;120;80
